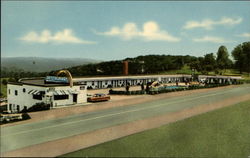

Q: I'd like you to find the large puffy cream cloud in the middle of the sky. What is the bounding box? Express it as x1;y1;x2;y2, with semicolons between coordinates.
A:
96;21;180;42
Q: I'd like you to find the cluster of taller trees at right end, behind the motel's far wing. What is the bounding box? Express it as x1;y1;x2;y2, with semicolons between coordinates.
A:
189;42;250;74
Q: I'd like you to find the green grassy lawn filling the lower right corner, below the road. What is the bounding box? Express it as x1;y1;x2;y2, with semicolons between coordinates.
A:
62;100;250;158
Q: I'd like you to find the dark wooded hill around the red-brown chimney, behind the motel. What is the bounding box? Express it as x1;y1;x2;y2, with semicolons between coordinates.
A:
61;55;196;76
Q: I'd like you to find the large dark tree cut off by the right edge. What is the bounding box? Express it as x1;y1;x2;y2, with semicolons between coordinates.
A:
232;42;250;75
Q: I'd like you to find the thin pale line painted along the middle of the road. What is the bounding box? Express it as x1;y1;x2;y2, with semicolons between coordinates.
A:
0;87;250;137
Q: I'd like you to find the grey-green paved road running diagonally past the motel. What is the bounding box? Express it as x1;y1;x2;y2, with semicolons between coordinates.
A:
1;85;250;152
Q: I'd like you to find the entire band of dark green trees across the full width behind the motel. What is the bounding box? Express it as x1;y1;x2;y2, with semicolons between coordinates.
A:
1;42;250;80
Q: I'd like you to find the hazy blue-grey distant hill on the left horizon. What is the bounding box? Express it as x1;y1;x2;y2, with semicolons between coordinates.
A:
1;57;100;72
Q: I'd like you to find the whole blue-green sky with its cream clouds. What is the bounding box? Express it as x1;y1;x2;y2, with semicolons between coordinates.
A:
1;1;250;61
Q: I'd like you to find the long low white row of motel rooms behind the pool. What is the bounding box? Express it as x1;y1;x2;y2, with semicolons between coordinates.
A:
73;75;241;89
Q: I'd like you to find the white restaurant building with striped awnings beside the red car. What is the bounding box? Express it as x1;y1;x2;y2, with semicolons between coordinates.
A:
7;79;87;113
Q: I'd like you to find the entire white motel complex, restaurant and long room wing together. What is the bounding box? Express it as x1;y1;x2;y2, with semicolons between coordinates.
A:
7;70;242;112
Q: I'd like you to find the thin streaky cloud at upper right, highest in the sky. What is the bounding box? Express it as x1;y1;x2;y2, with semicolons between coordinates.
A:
183;17;242;30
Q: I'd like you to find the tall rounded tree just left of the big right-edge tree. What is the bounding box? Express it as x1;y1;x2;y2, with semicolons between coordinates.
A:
216;46;232;73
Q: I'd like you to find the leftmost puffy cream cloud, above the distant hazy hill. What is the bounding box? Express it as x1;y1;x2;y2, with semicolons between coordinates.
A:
19;29;95;44
